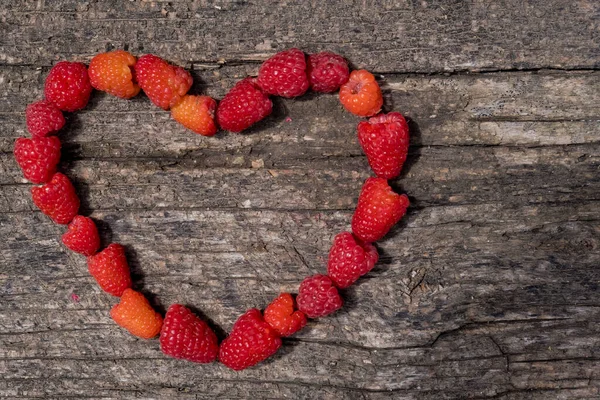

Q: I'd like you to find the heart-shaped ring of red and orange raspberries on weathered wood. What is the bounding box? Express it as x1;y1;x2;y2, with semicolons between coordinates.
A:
14;49;409;370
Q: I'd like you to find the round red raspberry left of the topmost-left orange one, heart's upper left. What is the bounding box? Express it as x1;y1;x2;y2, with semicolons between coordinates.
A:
44;61;92;112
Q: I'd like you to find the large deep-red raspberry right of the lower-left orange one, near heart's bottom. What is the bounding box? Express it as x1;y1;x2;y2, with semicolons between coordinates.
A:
160;304;219;364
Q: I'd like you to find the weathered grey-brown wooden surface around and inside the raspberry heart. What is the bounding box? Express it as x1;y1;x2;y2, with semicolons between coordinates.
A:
0;0;600;400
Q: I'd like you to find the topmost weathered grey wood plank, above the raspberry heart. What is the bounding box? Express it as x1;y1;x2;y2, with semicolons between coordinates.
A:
0;0;600;72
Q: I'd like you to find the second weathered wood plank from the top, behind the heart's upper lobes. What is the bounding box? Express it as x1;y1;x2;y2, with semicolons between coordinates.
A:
0;67;600;158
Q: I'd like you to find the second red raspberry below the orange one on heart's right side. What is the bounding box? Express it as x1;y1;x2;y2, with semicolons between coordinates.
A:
352;178;409;242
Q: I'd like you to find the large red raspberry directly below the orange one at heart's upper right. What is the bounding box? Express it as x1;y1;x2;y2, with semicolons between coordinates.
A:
358;112;409;179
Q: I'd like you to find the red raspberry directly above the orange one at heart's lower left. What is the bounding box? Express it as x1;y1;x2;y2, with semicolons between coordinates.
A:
88;243;131;297
